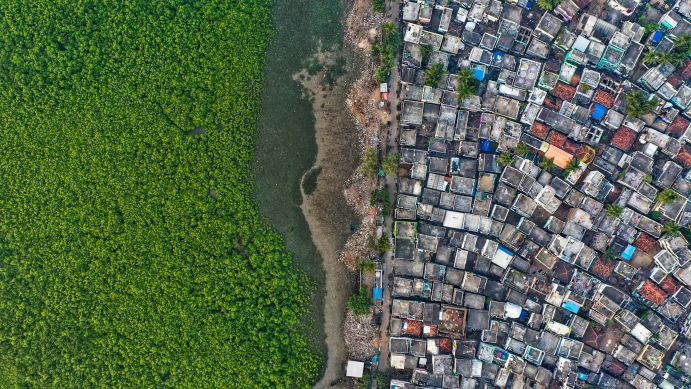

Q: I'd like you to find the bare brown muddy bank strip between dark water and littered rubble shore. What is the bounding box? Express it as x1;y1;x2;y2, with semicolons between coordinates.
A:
296;53;358;388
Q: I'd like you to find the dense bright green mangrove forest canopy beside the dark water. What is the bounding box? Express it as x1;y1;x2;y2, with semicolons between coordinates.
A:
0;0;319;388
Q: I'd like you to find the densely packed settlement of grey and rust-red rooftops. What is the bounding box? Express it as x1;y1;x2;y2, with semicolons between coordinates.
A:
390;0;691;388
